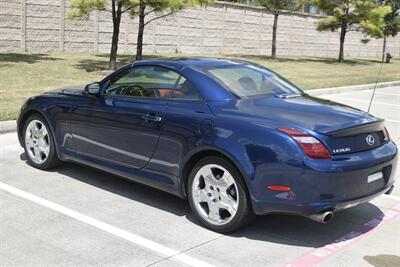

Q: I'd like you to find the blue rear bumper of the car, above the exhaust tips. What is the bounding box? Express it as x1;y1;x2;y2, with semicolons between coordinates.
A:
252;142;398;216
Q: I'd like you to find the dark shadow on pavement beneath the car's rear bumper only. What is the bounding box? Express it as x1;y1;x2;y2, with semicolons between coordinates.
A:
228;203;383;248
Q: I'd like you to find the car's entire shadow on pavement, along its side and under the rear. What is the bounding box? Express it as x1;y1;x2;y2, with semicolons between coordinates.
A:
20;153;383;248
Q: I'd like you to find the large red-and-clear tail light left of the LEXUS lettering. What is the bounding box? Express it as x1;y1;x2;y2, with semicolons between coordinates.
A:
277;128;332;159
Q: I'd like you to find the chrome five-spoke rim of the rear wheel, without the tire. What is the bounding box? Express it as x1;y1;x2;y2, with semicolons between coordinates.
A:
192;164;239;225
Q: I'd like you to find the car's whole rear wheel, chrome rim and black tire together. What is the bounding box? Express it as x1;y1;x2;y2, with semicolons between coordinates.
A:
188;156;254;233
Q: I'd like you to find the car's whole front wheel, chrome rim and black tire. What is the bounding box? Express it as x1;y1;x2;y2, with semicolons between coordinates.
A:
24;114;59;170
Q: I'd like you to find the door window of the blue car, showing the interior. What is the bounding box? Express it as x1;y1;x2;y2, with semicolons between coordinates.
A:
105;66;179;98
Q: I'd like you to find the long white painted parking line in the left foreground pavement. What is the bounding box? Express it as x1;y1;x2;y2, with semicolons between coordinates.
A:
0;182;216;267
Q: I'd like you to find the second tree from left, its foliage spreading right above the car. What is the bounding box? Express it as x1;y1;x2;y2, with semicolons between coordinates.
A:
132;0;214;60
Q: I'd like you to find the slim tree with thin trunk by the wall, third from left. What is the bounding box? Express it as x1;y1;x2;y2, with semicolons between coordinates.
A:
254;0;304;59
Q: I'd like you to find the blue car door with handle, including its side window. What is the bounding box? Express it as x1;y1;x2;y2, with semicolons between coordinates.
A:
71;66;179;169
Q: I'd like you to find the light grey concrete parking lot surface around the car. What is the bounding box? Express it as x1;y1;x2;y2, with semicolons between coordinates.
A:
0;87;400;266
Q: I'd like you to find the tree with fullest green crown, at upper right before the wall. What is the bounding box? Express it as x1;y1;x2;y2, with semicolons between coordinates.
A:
310;0;391;62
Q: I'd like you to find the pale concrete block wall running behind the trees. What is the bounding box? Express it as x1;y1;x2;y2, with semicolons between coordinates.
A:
0;0;400;56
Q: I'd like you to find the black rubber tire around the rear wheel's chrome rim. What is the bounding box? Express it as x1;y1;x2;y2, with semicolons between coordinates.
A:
187;156;255;233
